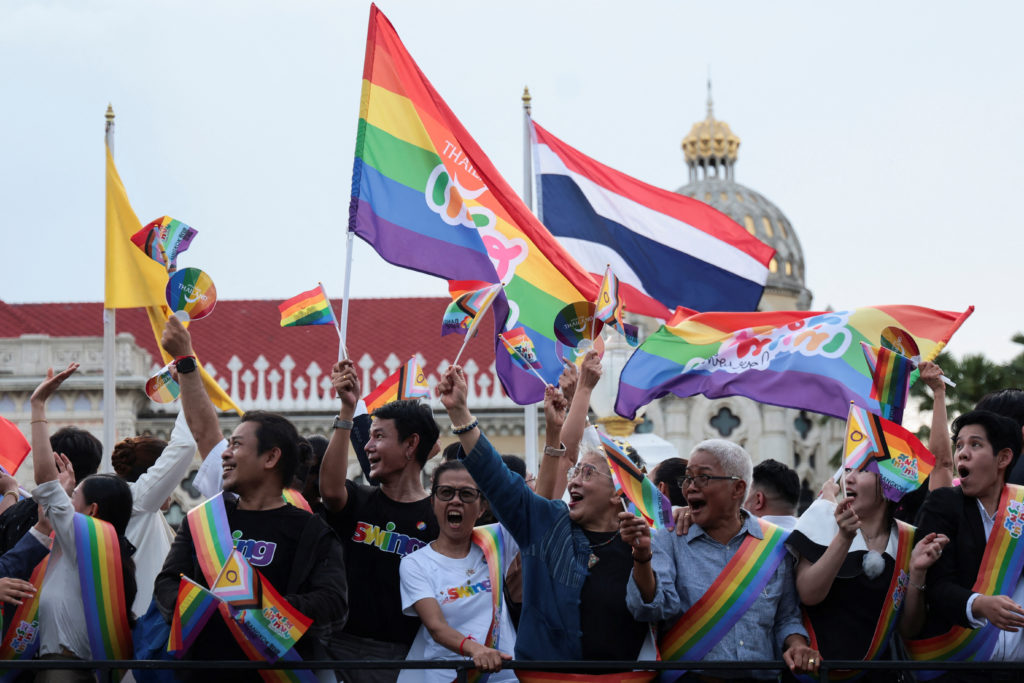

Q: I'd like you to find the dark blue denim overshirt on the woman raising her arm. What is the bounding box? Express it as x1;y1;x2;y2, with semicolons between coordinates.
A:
463;434;590;659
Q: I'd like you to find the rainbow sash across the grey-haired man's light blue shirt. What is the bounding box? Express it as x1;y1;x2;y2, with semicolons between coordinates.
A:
659;518;790;677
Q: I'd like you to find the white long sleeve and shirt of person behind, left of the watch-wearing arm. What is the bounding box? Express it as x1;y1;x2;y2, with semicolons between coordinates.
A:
125;411;196;616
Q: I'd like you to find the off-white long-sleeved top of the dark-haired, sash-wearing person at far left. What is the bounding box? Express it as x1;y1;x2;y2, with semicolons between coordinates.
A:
32;479;92;659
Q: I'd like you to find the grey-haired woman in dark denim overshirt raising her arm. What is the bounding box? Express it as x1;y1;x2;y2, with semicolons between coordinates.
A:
437;366;654;681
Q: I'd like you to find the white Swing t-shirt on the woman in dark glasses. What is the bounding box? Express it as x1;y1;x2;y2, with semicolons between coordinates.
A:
398;531;519;683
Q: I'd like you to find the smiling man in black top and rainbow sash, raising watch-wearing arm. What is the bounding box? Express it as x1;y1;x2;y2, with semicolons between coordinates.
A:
154;317;348;681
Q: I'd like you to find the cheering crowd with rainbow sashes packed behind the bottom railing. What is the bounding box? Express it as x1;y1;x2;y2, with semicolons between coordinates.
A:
0;317;1024;683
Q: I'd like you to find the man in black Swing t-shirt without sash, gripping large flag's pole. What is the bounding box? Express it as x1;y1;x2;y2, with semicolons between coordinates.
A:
321;360;439;683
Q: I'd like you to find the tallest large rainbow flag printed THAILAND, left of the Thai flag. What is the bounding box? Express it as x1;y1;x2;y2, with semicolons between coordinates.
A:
349;5;598;404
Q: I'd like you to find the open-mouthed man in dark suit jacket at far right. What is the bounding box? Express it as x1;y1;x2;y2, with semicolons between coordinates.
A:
911;411;1024;679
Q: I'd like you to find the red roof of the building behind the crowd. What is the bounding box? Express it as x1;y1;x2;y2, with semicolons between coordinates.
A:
0;298;494;405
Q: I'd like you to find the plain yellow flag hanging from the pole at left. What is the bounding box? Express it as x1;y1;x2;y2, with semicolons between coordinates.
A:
103;147;243;415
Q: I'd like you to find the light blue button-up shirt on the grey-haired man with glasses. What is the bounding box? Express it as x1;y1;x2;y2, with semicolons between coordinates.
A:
626;510;807;678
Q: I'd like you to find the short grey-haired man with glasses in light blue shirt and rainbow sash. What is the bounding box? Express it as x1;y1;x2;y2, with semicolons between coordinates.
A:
620;439;821;680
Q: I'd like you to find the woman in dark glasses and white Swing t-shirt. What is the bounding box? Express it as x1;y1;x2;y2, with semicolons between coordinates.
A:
398;460;519;683
